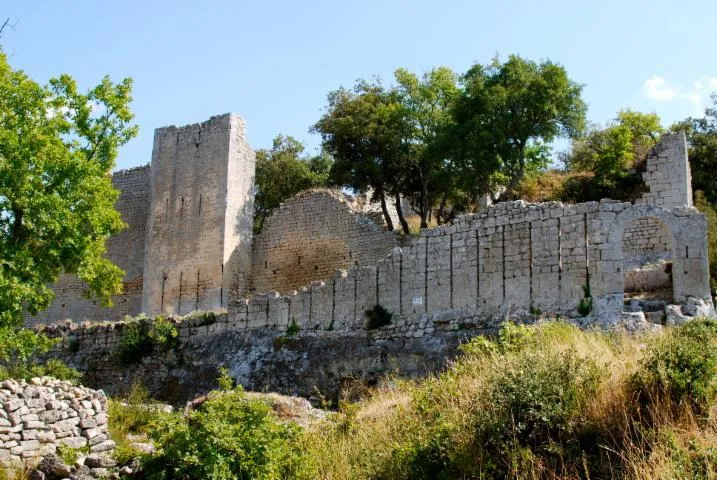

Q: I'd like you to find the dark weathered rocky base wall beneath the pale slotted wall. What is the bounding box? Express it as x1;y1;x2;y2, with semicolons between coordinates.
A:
44;310;500;404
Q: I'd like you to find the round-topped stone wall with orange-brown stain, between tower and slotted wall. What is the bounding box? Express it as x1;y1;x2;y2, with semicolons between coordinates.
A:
252;190;397;293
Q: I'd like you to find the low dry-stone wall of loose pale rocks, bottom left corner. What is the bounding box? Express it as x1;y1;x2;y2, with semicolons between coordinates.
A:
0;377;115;465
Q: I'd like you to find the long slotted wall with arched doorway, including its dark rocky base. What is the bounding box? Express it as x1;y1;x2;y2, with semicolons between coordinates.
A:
42;201;709;401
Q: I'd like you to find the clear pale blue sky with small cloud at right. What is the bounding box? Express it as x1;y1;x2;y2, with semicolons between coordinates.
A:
0;0;717;168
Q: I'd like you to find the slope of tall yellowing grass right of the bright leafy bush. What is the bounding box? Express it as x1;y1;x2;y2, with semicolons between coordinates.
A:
294;322;717;479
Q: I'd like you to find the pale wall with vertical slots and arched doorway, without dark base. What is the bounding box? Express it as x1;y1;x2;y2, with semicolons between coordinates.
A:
242;201;709;330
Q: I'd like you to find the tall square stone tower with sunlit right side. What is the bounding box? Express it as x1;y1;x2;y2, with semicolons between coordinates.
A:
142;114;255;315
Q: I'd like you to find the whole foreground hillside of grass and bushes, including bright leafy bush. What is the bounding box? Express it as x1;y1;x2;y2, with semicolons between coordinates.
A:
113;320;717;480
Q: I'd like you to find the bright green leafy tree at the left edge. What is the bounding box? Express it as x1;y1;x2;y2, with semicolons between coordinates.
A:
0;52;137;324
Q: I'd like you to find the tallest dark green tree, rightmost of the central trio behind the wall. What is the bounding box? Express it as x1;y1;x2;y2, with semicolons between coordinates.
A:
453;55;586;200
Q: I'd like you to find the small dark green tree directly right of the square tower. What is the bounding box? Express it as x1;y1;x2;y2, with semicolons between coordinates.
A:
254;134;331;232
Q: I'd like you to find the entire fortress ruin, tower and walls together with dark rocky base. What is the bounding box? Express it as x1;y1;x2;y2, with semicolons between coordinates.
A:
27;114;714;400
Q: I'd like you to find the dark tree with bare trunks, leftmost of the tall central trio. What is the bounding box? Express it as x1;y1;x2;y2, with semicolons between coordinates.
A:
311;80;411;233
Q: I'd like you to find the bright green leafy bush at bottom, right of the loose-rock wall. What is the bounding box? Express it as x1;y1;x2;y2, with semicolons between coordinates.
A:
143;388;301;480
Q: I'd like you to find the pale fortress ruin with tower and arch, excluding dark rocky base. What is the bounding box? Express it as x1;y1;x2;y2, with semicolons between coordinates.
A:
29;114;710;329
